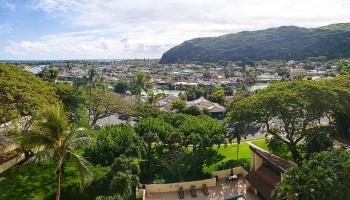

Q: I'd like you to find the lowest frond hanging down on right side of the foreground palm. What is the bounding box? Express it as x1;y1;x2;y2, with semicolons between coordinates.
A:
67;151;93;190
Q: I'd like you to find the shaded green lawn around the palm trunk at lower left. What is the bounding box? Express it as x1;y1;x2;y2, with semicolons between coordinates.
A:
0;164;109;200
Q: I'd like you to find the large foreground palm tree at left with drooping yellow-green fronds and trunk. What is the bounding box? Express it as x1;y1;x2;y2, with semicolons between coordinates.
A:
25;104;92;200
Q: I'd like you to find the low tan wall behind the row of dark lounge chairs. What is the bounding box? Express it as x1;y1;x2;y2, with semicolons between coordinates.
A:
145;178;216;194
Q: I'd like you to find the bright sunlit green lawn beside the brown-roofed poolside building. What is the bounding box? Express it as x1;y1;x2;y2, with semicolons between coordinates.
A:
204;139;268;173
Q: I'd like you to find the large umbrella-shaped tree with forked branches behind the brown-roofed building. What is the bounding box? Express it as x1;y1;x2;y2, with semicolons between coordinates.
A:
228;81;338;164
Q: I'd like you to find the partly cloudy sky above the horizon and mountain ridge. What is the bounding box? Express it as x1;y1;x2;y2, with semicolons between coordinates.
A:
0;0;350;60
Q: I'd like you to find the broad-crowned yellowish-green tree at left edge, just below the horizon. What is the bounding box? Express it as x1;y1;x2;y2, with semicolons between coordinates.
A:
0;63;57;126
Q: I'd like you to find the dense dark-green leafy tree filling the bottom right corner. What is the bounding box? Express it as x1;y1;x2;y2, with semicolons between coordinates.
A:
277;150;350;200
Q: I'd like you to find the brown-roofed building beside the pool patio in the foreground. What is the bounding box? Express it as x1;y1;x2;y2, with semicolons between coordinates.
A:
246;142;296;200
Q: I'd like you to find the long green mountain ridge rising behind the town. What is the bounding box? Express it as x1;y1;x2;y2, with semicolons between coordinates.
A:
160;23;350;64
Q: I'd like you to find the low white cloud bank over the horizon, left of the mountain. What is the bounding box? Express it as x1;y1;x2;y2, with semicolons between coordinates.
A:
5;30;175;59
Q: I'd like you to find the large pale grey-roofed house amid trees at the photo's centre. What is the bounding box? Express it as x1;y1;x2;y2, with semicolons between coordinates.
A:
187;97;226;119
